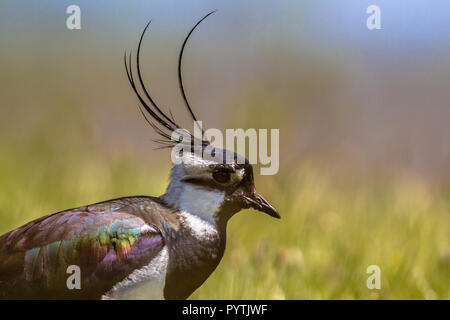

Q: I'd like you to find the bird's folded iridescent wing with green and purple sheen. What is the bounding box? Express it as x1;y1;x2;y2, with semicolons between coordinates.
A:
0;198;164;299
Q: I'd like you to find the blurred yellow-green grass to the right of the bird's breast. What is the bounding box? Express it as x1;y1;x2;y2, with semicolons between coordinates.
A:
193;162;450;299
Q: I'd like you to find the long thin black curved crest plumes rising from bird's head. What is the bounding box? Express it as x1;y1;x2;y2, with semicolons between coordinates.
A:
124;10;216;148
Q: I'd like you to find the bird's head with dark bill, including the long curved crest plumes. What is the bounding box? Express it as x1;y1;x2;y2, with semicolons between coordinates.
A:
124;11;280;222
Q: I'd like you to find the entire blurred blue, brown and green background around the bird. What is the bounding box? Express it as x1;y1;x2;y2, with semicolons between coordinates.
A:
0;0;450;299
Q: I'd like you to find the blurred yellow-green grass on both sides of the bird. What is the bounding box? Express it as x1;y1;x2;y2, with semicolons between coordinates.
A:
0;118;450;299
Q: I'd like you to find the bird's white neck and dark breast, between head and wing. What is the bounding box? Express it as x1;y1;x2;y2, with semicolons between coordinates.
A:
161;183;230;299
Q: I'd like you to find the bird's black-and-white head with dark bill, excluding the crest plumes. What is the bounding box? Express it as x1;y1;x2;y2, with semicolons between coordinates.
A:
163;148;280;222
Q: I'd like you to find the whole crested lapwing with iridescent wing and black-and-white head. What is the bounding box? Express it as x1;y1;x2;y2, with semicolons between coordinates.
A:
0;11;280;300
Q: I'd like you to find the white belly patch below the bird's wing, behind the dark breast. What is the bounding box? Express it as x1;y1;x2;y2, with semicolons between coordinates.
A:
102;247;169;300
